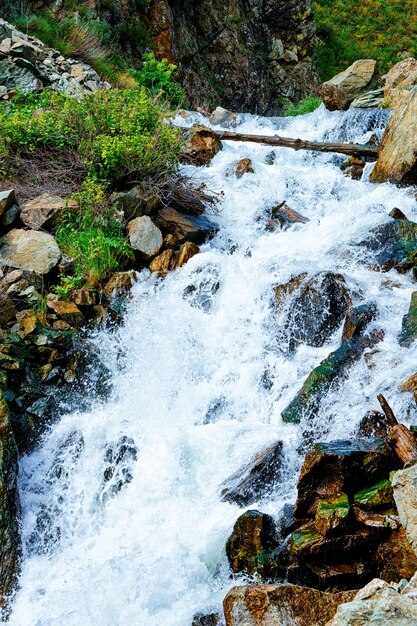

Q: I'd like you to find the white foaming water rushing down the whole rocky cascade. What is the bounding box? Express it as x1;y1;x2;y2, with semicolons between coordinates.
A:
10;108;417;626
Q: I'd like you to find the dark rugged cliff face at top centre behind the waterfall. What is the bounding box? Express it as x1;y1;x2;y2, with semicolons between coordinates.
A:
148;0;318;114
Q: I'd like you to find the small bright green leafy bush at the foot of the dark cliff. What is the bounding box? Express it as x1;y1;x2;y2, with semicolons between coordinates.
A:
132;53;185;106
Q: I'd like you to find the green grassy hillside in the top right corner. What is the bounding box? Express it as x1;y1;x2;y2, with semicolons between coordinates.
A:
314;0;417;81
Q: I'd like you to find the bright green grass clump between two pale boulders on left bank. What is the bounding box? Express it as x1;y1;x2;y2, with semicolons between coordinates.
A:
56;180;132;288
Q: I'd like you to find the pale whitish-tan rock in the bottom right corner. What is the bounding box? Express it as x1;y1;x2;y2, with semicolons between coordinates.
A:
327;579;417;626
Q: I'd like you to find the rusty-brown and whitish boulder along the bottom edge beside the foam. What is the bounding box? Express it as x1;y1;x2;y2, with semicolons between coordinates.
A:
223;584;355;626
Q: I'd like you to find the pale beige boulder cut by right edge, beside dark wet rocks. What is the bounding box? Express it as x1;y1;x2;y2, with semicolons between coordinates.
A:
390;465;417;554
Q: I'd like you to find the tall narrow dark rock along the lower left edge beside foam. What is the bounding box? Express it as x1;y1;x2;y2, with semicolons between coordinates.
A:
0;391;20;605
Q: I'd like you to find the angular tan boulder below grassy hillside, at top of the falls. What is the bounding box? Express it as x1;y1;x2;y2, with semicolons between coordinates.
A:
320;59;376;111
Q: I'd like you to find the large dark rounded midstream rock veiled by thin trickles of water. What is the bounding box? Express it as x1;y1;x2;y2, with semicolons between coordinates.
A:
276;272;351;350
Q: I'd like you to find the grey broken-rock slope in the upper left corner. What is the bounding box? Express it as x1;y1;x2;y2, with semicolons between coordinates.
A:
0;19;110;98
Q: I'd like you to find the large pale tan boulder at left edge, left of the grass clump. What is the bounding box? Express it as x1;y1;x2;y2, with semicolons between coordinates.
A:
0;228;61;275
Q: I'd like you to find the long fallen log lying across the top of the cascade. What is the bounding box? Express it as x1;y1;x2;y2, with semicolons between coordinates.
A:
177;128;378;159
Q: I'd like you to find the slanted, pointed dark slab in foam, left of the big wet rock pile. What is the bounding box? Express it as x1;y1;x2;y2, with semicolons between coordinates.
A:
221;441;283;506
